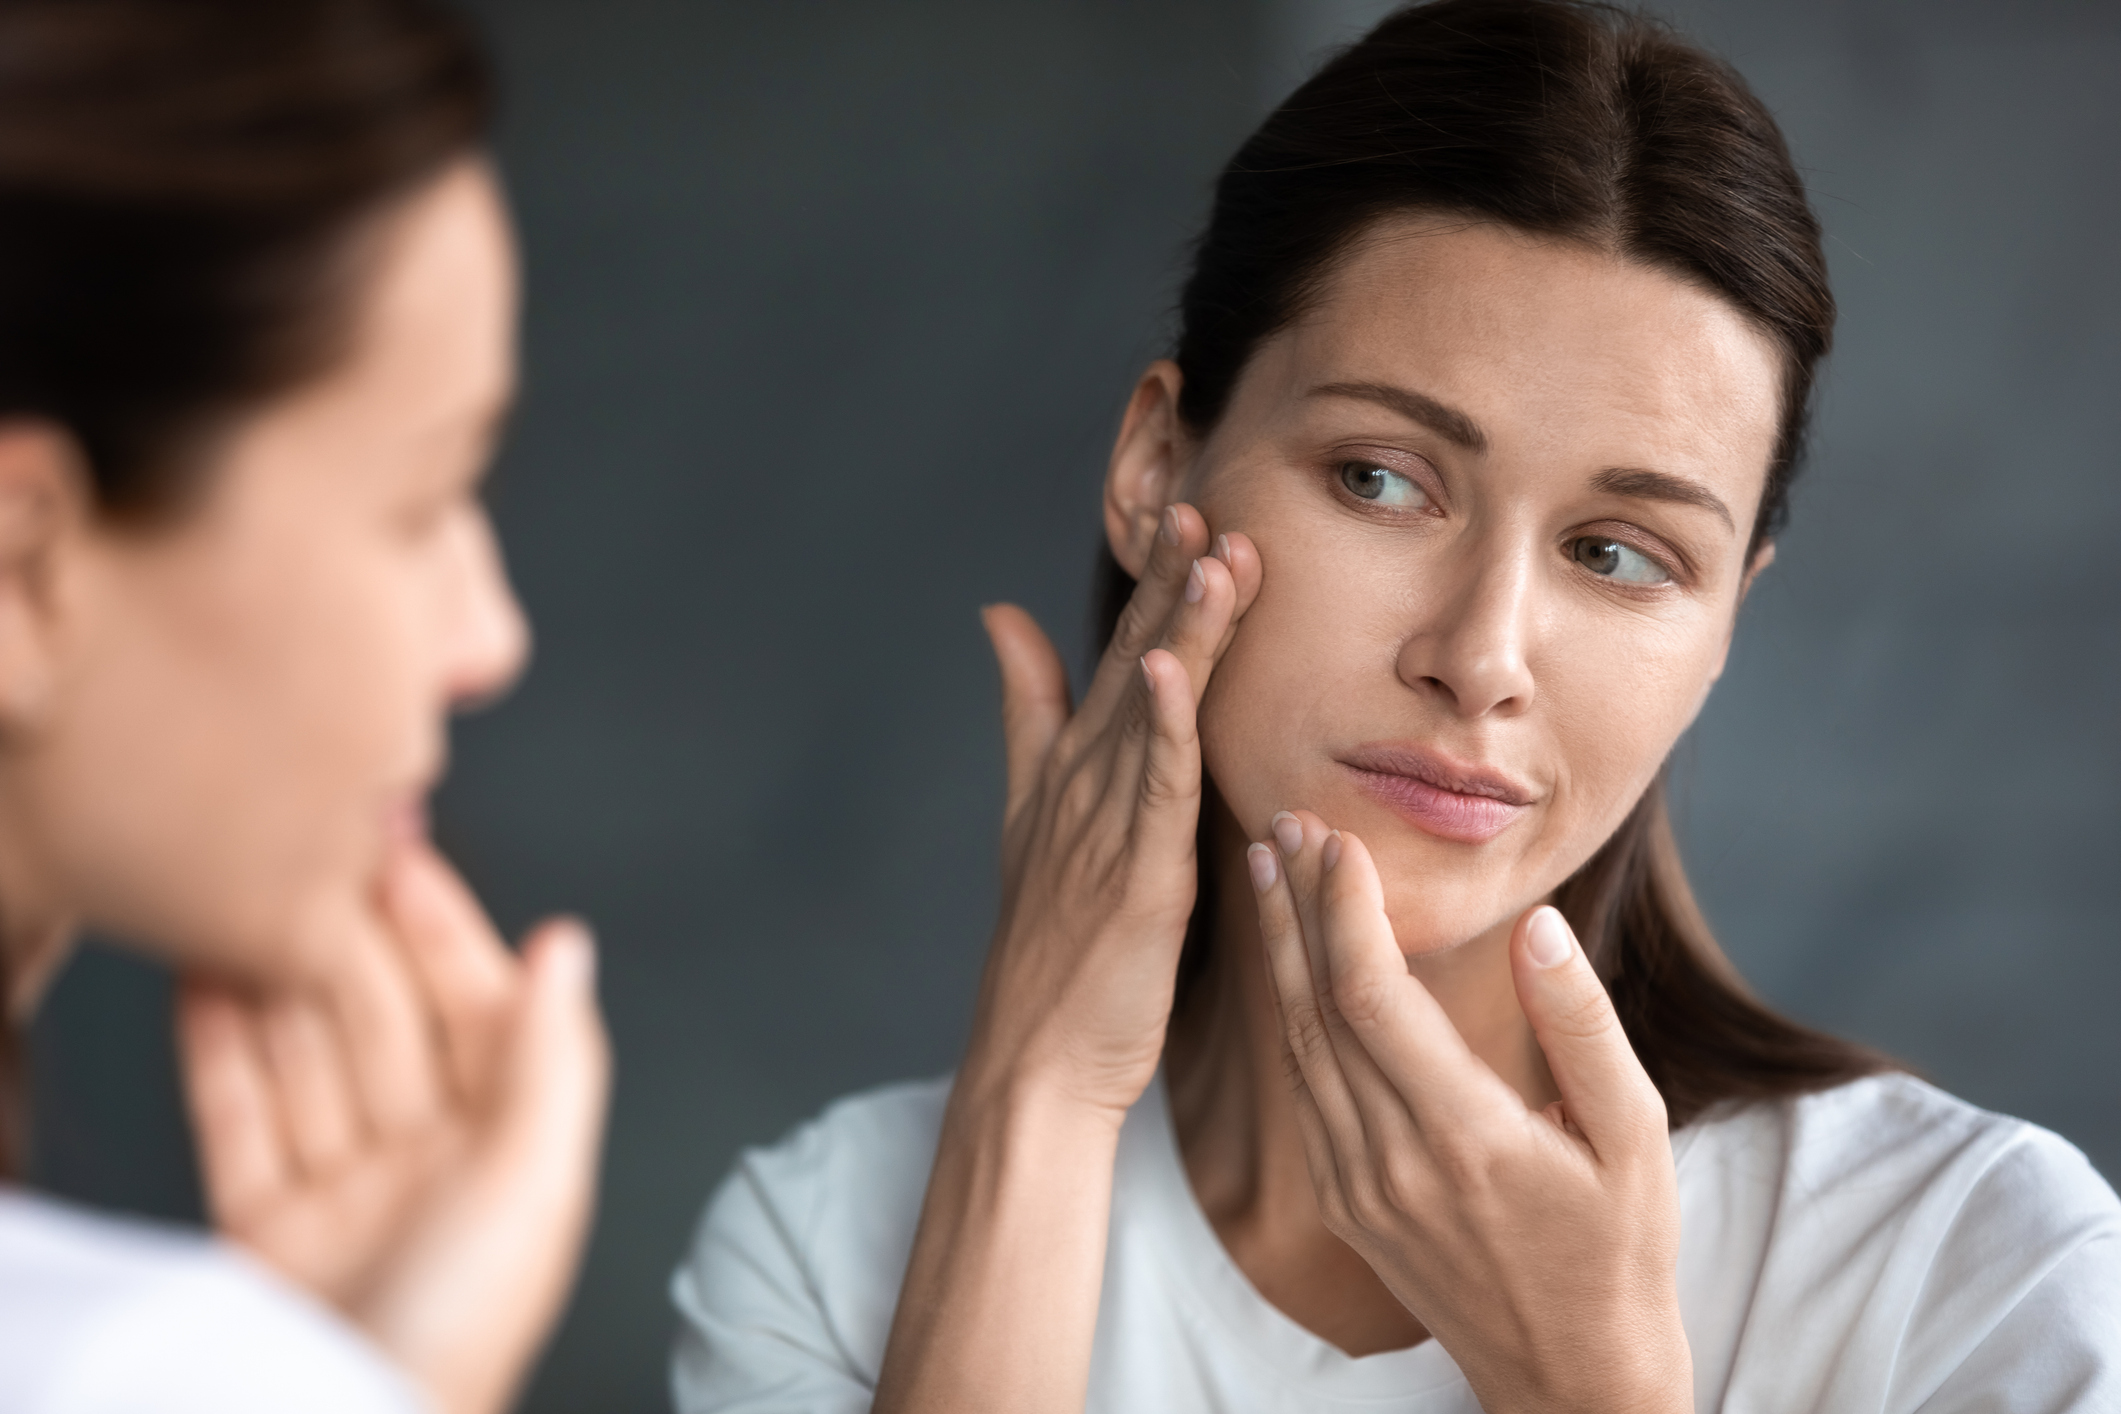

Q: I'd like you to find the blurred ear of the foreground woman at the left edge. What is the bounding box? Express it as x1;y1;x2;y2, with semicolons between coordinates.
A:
0;420;87;738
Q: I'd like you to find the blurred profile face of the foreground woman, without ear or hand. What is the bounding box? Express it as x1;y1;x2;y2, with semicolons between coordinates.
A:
8;161;526;979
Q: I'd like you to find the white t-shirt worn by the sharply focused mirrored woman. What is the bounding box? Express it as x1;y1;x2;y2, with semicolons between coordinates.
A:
672;1075;2121;1414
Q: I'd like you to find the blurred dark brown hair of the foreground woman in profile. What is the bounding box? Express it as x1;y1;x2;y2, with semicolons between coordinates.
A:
0;0;492;1174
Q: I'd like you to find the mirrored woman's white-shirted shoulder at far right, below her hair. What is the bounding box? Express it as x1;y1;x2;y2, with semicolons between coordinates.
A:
1676;1075;2121;1410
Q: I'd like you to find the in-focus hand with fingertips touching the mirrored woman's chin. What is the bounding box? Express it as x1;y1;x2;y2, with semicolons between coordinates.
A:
1247;812;1693;1414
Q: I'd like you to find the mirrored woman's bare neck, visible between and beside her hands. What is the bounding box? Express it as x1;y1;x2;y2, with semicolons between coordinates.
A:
1164;803;1557;1355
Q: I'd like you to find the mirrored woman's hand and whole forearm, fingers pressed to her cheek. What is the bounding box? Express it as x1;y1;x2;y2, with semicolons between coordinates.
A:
872;505;1260;1414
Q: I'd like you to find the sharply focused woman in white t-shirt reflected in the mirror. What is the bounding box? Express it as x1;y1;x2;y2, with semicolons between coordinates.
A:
677;0;2121;1412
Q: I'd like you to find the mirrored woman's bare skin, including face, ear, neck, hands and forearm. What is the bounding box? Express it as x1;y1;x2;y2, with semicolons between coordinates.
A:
876;218;1780;1412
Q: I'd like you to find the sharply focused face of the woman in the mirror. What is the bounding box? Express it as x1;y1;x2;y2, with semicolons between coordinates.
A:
1153;218;1780;954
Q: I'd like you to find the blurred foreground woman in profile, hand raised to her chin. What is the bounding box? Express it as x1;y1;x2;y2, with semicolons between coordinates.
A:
0;0;607;1414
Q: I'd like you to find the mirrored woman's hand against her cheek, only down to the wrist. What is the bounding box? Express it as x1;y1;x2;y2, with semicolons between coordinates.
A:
959;505;1260;1124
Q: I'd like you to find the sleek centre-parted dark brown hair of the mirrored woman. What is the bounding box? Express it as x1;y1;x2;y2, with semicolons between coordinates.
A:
1097;0;1890;1126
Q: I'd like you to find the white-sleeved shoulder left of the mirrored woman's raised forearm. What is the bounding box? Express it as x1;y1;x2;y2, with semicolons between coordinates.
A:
670;1079;950;1408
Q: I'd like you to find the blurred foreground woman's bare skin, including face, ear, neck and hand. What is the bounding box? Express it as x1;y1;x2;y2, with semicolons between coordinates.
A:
0;161;609;1414
